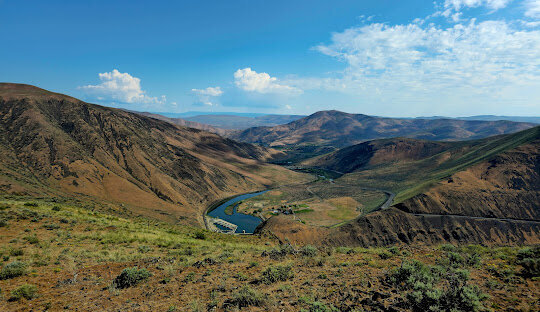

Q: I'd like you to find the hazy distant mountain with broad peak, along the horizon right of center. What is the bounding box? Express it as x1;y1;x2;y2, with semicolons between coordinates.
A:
231;111;535;147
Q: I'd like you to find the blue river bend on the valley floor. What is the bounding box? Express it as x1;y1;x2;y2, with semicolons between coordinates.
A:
208;191;268;233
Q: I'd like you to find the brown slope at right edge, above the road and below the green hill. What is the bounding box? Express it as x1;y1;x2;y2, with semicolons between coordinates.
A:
396;140;540;220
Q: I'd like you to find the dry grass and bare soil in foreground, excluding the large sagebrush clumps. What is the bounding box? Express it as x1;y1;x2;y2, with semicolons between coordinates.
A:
0;200;540;311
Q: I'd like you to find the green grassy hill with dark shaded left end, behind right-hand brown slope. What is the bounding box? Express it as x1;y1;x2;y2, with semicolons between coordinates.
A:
303;127;540;203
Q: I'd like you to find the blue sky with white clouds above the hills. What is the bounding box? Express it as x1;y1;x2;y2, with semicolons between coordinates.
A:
0;0;540;116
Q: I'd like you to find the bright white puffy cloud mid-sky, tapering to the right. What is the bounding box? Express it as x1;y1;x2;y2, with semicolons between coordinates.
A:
234;67;302;95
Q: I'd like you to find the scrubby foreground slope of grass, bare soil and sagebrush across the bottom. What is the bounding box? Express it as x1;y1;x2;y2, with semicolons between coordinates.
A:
0;199;540;311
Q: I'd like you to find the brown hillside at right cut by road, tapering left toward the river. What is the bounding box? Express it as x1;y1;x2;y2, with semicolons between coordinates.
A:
260;136;540;246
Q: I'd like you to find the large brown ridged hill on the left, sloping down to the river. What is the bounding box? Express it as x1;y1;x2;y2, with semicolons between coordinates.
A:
0;84;301;223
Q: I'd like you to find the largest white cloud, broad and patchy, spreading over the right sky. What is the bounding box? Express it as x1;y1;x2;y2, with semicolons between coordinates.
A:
310;19;540;108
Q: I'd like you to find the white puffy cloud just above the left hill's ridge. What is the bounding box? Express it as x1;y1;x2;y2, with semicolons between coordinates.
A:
79;69;166;104
